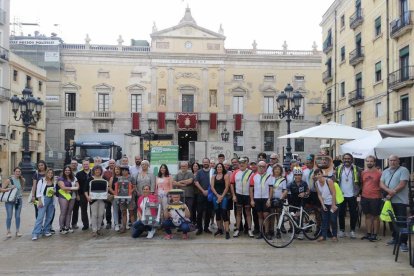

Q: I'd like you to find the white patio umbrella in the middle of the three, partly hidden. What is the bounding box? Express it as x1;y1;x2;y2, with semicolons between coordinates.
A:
340;130;382;159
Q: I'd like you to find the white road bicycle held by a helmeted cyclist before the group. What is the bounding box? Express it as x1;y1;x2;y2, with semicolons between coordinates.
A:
261;198;321;248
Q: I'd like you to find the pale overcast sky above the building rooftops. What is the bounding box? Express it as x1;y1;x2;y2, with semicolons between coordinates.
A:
10;0;333;50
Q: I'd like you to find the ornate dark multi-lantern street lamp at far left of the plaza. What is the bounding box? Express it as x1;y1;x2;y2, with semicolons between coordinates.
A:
10;87;43;189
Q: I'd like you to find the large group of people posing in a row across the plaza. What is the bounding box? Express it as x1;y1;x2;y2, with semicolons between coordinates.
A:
0;153;410;251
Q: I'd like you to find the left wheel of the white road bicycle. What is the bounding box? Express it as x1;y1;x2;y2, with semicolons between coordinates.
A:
261;213;295;248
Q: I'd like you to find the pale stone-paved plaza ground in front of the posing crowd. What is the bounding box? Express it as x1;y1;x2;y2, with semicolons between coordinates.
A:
0;199;414;275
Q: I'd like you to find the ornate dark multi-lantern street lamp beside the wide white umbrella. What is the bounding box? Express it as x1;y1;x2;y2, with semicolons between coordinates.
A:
276;84;303;167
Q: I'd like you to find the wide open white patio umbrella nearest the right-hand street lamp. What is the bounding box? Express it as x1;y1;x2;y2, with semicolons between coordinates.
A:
278;122;370;140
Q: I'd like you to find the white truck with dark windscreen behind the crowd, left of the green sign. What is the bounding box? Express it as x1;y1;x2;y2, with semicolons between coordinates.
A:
71;133;141;163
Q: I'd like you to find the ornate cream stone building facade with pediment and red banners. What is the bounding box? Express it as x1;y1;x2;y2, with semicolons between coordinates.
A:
12;8;322;164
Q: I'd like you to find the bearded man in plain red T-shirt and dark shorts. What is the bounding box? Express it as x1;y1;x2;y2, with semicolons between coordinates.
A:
361;155;382;241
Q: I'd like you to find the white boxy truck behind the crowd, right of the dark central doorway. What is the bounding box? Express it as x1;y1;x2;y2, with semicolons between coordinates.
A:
189;141;233;163
